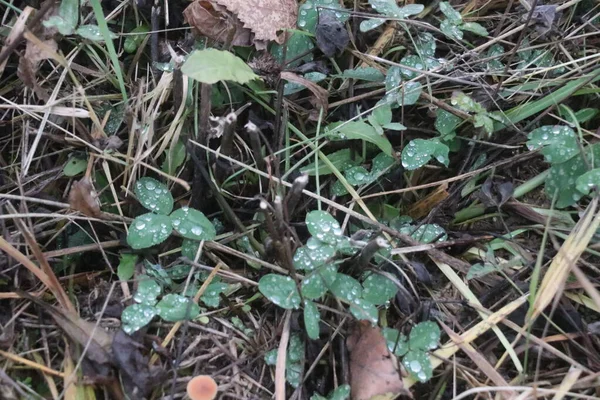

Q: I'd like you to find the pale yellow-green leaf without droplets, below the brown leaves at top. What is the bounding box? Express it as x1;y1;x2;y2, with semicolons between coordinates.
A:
181;49;258;84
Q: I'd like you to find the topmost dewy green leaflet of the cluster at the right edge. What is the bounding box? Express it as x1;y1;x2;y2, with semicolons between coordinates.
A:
527;125;580;164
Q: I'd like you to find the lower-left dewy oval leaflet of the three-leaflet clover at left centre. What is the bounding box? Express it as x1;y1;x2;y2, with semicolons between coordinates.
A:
127;213;173;249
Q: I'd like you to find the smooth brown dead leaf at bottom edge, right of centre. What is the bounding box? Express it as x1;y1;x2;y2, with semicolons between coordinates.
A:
347;321;406;400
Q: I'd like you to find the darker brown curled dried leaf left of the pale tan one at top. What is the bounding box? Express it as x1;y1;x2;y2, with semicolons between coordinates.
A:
183;0;252;46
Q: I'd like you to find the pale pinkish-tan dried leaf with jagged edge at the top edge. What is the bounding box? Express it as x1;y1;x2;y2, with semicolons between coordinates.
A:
214;0;298;44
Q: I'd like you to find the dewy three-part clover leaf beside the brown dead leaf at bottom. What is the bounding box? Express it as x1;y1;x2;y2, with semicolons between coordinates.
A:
382;321;441;382
